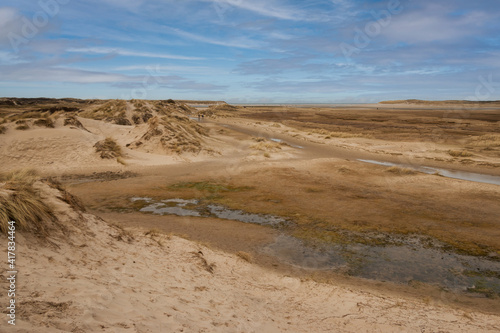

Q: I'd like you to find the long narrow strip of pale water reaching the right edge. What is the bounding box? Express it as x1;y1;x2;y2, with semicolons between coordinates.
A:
358;159;500;185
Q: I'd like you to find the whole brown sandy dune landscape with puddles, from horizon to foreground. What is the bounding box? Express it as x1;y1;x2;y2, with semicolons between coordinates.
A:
0;100;500;332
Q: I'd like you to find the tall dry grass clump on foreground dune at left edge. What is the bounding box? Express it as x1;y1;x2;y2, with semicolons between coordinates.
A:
0;170;54;234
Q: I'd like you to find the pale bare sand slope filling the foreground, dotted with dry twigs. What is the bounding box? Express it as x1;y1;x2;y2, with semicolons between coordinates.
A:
0;185;500;332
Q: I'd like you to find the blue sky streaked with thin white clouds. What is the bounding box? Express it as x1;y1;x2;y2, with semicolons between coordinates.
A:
0;0;500;103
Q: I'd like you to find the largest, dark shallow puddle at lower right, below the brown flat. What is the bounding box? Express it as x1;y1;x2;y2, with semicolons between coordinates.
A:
262;235;500;294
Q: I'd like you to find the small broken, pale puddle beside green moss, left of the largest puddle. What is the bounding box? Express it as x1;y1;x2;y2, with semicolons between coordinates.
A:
130;198;289;227
